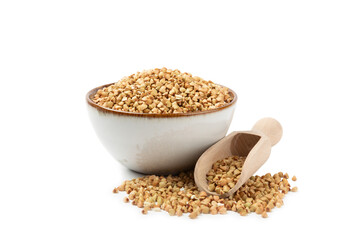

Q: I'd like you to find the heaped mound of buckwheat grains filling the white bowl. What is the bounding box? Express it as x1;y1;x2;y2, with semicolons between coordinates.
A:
93;68;232;114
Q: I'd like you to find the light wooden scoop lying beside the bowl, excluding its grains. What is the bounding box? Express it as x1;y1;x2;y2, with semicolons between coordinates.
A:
194;118;282;197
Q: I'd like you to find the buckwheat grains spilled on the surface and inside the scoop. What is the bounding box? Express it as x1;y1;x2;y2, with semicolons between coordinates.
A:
113;156;297;219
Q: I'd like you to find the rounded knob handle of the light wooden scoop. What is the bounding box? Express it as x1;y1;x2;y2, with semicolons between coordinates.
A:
252;118;283;146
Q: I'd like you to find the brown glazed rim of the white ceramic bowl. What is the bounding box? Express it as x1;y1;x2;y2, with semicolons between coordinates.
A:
86;83;237;118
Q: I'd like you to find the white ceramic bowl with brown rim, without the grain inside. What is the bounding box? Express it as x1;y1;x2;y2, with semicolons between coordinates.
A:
86;84;237;174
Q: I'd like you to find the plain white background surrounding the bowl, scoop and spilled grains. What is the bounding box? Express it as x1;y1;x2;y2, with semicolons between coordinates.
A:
0;0;360;240
